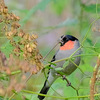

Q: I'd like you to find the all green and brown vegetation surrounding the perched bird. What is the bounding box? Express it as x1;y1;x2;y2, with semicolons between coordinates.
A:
0;0;100;100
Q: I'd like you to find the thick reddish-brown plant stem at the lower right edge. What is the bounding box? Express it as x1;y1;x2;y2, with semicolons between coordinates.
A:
90;55;100;100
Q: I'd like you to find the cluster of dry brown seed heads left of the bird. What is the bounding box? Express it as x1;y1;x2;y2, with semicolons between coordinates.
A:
0;0;43;95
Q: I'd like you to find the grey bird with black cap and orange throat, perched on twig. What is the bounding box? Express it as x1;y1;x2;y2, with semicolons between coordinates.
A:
38;35;81;100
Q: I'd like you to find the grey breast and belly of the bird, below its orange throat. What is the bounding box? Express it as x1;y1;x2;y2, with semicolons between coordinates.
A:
53;45;81;75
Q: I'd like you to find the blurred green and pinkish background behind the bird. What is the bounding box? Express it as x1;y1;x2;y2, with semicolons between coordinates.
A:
1;0;100;100
